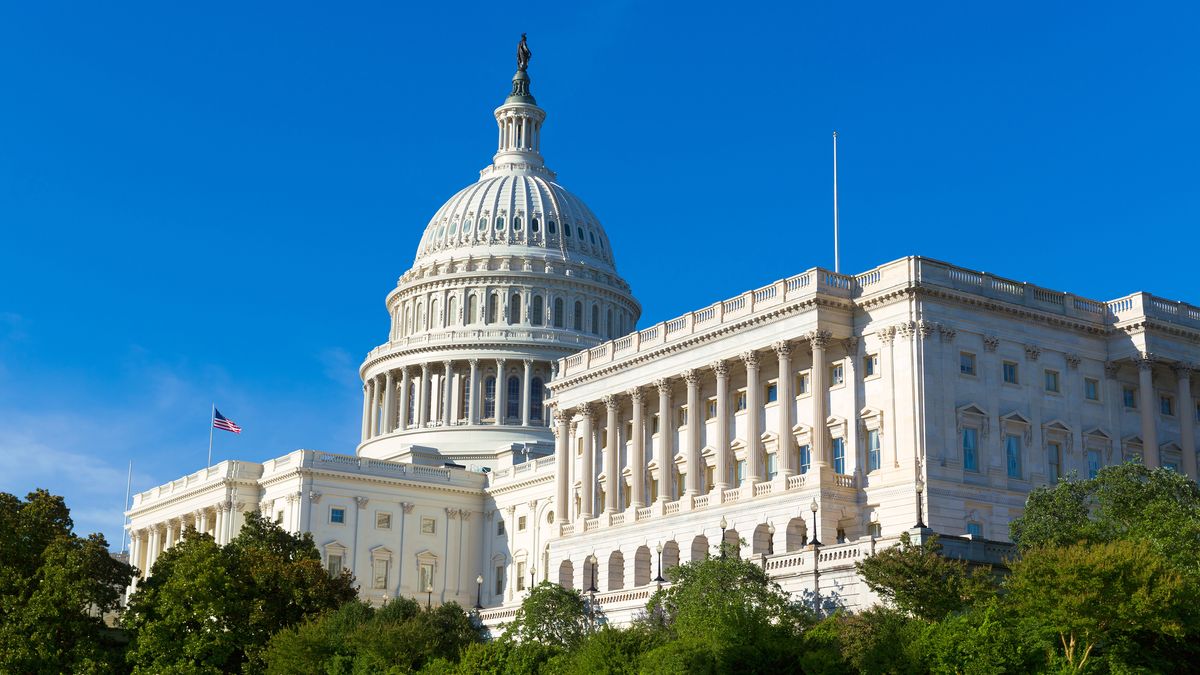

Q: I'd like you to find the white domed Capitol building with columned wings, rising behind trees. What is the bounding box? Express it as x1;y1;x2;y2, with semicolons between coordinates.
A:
127;43;1200;626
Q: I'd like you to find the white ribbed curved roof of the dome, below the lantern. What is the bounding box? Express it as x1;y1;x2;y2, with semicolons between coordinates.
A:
416;172;614;269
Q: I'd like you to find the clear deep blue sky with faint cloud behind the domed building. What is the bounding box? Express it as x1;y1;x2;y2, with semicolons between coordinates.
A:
0;2;1200;544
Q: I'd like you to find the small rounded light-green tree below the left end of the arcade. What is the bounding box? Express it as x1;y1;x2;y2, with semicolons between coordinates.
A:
505;581;602;650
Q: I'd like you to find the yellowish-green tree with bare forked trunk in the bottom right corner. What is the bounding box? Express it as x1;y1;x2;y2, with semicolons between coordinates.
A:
1006;540;1200;673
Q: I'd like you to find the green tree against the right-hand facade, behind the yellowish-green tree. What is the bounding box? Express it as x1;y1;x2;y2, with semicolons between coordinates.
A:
1009;462;1200;577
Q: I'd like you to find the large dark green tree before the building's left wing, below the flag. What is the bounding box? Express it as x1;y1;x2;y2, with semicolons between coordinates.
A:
125;513;355;673
